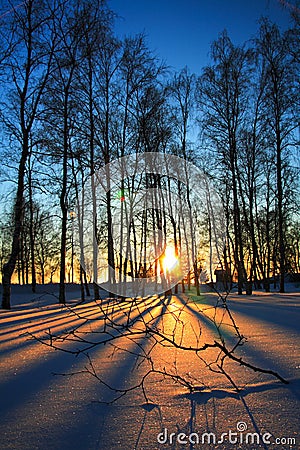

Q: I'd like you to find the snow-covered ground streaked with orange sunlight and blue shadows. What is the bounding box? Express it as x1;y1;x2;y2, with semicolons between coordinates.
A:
0;286;300;450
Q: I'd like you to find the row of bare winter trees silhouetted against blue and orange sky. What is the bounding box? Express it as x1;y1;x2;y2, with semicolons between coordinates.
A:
0;0;300;308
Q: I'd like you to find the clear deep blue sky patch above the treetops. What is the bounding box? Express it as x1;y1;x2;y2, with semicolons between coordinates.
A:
108;0;295;73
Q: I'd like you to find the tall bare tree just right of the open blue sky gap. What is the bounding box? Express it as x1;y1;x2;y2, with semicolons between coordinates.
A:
197;32;251;294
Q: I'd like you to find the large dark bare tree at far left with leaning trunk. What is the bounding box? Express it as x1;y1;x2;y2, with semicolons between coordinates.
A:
2;0;56;309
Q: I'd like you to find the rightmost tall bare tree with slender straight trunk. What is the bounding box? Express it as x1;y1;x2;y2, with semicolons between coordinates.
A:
256;19;299;292
